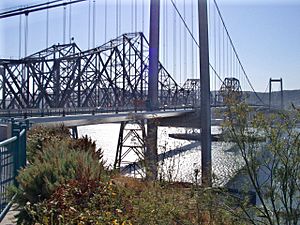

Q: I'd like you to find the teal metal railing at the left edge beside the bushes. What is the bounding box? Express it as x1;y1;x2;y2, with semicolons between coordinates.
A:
0;122;26;222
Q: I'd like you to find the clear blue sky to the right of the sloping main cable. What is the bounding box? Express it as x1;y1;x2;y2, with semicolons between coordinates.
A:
220;0;300;90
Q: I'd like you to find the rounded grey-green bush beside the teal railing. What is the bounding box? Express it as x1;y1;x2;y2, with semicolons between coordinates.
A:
14;141;105;224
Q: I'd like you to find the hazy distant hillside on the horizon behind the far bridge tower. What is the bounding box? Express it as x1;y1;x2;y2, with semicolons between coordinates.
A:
243;90;300;108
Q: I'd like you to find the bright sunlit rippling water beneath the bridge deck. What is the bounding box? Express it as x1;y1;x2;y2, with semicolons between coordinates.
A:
78;124;241;185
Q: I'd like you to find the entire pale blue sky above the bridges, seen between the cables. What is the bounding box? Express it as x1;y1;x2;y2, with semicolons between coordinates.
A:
0;0;300;92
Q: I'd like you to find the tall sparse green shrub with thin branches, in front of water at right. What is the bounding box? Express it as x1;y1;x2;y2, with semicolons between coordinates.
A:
225;103;300;225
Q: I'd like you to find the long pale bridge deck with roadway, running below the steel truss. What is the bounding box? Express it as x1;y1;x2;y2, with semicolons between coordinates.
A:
0;107;270;128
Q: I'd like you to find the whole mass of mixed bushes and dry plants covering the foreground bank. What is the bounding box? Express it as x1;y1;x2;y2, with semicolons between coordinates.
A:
14;124;247;225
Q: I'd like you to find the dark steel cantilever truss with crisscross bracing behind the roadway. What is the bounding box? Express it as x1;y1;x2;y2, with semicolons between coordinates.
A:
0;33;197;109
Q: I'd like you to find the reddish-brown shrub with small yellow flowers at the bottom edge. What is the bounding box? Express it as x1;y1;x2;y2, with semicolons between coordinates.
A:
26;179;131;225
